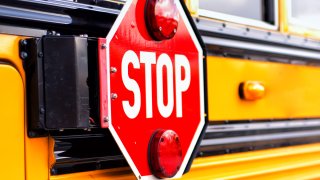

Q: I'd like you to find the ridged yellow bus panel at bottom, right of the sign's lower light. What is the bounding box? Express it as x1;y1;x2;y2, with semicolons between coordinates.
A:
183;144;320;180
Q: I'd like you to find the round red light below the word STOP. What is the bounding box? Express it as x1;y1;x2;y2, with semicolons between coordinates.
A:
149;130;182;178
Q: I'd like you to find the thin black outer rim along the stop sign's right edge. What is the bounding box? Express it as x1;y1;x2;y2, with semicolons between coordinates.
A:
180;0;209;173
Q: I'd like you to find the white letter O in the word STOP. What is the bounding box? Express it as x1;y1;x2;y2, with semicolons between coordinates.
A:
157;54;173;118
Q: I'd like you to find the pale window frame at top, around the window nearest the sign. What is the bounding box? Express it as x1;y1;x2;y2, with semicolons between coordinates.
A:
198;0;279;30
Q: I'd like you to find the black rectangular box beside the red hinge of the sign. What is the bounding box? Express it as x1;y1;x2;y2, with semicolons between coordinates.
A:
43;36;89;129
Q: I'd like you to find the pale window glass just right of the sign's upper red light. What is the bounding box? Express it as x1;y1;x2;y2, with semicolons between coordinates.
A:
199;0;264;21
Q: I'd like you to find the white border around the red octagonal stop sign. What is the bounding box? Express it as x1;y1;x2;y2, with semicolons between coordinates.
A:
106;0;205;180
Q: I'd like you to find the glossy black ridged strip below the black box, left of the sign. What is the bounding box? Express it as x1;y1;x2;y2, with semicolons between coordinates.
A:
51;129;128;175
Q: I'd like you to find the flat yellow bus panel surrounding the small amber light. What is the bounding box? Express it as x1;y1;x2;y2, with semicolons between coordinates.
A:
207;56;320;120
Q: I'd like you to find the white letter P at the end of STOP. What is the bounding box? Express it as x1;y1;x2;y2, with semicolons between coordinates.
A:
175;55;190;117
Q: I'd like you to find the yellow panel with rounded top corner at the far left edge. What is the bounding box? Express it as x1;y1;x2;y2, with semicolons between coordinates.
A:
0;65;25;180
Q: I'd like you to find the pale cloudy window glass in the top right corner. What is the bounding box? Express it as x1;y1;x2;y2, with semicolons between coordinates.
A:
291;0;320;29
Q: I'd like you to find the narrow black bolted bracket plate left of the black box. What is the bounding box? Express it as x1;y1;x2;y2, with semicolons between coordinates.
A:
20;38;46;137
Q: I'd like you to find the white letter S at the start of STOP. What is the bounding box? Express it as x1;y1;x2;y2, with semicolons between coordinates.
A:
121;50;141;119
